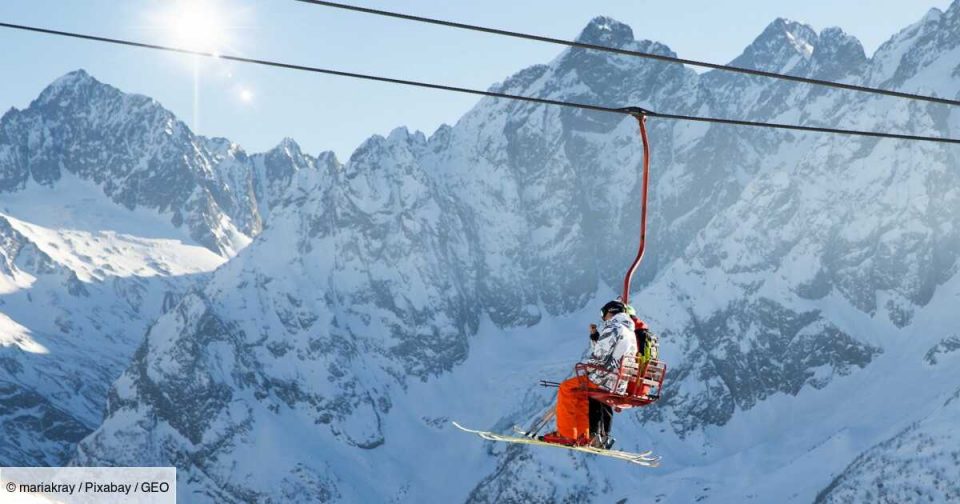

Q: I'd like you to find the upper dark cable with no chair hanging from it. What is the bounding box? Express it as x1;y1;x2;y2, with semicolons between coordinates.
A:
295;0;960;106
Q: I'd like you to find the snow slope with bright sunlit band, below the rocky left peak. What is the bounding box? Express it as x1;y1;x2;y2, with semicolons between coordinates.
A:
0;175;224;465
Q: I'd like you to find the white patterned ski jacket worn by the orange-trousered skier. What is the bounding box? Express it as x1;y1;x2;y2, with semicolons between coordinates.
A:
587;313;637;394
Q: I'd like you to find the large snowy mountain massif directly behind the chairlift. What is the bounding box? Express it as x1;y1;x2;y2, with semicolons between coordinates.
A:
7;1;960;503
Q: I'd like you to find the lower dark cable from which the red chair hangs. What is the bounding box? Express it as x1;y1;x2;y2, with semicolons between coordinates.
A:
0;22;960;144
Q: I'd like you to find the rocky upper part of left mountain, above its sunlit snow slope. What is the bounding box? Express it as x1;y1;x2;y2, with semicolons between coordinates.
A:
0;70;326;256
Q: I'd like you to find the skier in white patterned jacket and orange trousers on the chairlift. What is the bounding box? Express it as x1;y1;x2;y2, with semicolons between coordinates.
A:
540;301;637;449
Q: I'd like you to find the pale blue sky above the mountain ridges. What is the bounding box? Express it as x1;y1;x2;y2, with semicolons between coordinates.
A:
0;0;960;159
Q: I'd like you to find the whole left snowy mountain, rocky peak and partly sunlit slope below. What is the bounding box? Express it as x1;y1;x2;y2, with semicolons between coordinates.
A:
0;71;326;466
